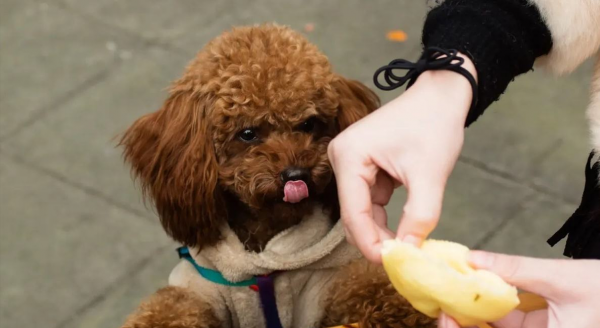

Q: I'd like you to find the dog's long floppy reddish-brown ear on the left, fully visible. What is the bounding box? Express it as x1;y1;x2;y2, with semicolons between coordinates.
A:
120;90;226;248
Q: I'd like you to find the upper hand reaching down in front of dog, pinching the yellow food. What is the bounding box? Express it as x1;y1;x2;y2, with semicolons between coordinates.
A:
328;57;476;263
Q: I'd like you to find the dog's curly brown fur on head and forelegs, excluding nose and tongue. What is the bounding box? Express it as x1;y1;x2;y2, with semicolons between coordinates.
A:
121;25;433;328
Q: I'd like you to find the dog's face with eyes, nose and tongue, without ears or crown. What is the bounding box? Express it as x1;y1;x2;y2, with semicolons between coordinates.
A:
212;91;338;209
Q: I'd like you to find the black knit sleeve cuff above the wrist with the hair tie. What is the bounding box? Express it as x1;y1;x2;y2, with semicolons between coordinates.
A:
423;0;552;126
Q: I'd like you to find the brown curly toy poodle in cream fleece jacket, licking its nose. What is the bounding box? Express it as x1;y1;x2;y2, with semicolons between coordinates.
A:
121;25;435;328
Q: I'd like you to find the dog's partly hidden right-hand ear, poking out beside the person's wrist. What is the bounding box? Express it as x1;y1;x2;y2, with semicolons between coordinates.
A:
334;76;379;131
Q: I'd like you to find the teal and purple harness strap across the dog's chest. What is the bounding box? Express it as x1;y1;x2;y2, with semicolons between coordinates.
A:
177;247;283;328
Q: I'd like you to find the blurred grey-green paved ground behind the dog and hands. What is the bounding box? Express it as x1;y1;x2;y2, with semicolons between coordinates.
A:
0;0;591;328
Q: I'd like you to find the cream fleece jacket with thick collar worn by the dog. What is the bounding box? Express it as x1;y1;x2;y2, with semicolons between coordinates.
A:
169;209;360;328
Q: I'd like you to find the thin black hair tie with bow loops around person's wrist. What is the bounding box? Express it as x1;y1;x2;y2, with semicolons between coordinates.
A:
373;47;477;112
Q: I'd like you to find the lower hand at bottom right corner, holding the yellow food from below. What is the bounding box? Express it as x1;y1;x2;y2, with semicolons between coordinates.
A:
439;251;600;328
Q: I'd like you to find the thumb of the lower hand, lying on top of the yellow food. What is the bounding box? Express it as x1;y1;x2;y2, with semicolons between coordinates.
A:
469;251;569;298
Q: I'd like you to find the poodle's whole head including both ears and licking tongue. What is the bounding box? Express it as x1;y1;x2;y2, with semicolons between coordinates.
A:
122;25;379;247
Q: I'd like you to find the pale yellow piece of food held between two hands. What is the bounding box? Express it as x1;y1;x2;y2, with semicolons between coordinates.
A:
381;240;519;326
